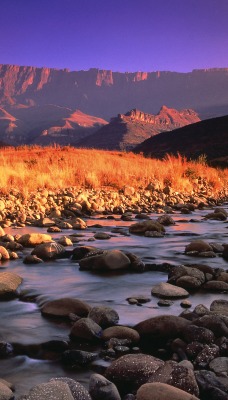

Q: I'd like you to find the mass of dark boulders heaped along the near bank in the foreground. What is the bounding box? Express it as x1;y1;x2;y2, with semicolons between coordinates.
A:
0;290;228;400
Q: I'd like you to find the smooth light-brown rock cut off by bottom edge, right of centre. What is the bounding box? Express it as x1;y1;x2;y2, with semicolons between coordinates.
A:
136;382;199;400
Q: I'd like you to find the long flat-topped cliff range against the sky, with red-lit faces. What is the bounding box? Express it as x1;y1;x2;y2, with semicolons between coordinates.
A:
0;65;228;120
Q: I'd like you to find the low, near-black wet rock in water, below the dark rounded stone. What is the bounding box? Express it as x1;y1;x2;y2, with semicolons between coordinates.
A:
62;350;97;368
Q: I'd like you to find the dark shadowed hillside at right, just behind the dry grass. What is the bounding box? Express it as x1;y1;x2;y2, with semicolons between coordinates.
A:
134;115;228;163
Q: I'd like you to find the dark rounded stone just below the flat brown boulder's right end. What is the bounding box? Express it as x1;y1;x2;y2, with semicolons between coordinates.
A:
70;318;102;340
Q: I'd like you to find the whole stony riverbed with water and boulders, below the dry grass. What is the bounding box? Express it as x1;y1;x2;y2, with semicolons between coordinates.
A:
0;186;228;400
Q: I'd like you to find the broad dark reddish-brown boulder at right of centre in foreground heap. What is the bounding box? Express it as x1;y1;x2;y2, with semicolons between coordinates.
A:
134;315;190;342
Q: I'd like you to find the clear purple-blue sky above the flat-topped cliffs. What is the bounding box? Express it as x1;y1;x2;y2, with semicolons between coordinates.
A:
0;0;228;72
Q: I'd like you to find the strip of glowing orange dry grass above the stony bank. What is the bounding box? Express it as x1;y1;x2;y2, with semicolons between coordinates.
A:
0;146;228;197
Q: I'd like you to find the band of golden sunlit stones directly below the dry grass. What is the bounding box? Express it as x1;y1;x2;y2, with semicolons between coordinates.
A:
0;183;228;225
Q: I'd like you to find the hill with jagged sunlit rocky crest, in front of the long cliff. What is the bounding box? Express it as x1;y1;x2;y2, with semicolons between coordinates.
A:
78;106;200;150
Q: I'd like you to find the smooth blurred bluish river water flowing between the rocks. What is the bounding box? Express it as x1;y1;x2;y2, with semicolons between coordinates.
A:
0;205;228;398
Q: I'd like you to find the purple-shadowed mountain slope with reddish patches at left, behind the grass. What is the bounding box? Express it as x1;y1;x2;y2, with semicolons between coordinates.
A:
0;104;107;145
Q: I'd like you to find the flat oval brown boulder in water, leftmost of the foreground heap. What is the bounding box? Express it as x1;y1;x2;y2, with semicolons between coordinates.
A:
41;297;91;318
